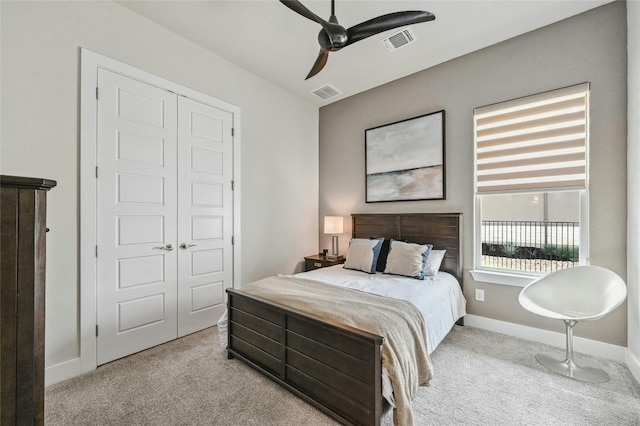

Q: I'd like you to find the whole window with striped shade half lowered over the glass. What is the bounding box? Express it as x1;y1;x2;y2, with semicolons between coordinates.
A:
474;83;589;275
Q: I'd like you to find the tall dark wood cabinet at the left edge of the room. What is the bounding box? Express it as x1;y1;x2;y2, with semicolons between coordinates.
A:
0;176;56;426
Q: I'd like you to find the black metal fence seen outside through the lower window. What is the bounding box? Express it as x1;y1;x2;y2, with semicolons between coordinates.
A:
482;220;580;273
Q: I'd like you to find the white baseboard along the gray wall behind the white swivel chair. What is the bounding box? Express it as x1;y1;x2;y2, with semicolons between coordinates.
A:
464;315;624;362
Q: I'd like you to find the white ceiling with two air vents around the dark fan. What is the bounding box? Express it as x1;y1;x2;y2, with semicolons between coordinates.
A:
119;0;612;106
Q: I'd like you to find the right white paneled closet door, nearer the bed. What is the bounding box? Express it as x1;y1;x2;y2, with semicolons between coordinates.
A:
178;96;233;336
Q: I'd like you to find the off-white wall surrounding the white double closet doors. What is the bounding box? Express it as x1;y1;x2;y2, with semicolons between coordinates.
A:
0;2;318;382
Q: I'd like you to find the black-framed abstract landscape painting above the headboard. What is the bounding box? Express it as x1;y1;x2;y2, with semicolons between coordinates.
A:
365;110;445;203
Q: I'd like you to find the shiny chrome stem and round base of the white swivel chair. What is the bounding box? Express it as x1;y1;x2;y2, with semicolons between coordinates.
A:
536;320;609;383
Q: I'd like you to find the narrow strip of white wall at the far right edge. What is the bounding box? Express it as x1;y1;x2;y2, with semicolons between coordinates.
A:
627;1;640;381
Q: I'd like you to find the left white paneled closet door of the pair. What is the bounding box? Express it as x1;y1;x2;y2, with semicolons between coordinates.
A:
97;69;178;365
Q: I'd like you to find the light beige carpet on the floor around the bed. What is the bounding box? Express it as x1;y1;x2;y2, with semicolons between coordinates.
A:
45;326;640;426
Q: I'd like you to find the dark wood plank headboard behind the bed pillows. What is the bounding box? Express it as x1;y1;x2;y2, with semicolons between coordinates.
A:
351;213;462;285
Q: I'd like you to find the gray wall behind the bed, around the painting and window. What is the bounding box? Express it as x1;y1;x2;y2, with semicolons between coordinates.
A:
319;2;627;346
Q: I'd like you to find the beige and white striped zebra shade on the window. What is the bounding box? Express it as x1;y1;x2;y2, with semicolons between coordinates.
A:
474;83;589;193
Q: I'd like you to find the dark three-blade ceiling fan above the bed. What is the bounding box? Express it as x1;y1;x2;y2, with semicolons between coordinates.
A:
280;0;436;80
